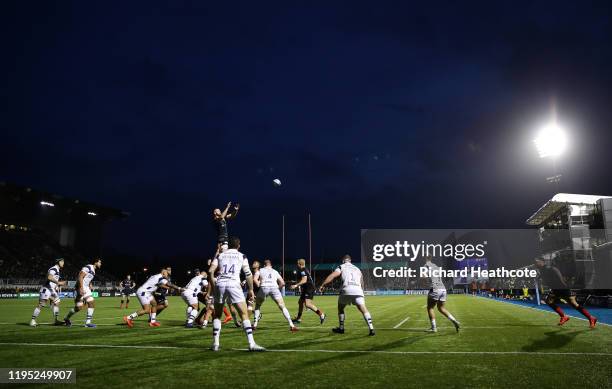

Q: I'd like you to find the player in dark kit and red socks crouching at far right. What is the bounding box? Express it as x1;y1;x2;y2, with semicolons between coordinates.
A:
535;258;597;328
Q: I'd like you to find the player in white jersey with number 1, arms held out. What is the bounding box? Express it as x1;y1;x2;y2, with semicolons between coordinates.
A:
319;255;376;336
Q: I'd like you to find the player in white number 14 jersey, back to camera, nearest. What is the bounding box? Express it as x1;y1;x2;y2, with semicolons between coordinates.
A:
209;237;265;351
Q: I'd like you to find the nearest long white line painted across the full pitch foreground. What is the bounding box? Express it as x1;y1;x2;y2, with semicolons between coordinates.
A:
0;342;612;357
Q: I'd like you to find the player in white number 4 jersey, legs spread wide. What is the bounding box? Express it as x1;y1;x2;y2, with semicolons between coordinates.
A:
253;259;298;332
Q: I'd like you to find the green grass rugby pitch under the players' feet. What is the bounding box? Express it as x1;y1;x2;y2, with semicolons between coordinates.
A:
0;295;612;388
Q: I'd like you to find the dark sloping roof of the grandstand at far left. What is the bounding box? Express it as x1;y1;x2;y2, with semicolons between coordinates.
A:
0;181;130;219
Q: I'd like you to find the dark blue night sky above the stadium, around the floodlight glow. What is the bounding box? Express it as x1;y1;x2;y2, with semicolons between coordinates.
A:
0;1;612;258
